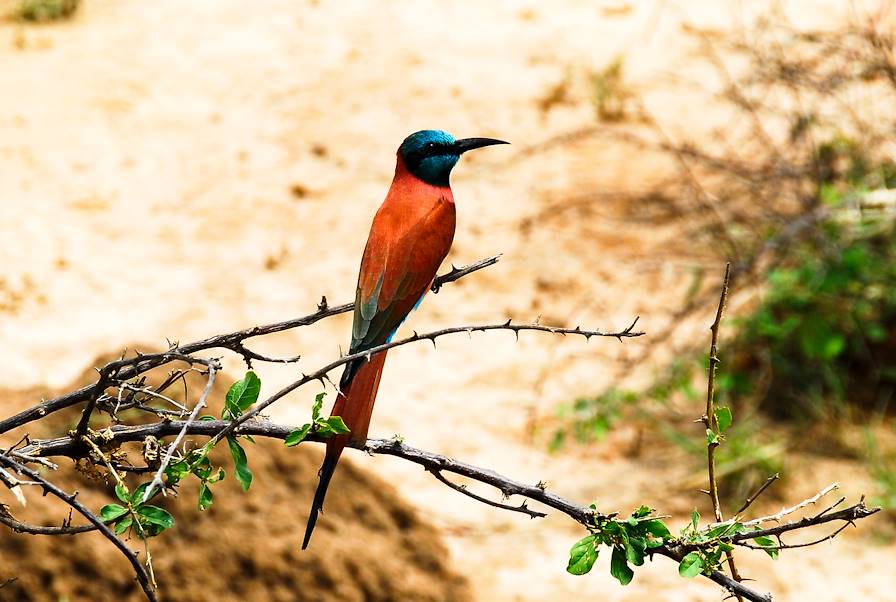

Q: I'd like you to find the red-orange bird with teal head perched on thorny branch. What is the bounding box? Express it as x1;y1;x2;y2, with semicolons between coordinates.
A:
302;130;509;550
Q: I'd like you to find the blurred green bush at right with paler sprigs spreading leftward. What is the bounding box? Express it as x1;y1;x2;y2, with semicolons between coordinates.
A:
550;123;896;502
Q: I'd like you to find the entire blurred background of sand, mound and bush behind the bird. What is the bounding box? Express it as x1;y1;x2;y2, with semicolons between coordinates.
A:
0;0;896;601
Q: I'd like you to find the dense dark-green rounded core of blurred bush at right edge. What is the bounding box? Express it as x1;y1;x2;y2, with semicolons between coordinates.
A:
727;214;896;421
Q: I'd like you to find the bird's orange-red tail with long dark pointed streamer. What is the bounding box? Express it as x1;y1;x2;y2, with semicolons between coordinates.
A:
302;351;386;550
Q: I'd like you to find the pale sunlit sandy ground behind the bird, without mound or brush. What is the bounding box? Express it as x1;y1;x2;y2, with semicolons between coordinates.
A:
0;0;896;601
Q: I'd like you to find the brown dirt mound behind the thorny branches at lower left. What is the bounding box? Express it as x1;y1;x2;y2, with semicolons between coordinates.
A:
0;352;470;602
